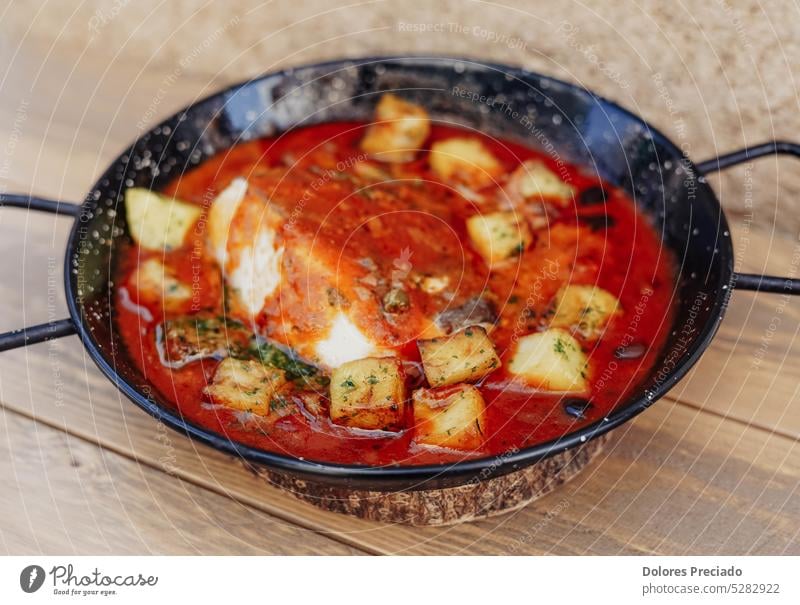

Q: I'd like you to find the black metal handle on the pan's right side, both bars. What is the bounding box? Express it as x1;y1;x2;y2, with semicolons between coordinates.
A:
697;141;800;294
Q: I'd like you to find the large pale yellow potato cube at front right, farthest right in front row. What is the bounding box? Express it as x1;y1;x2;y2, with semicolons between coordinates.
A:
508;328;588;393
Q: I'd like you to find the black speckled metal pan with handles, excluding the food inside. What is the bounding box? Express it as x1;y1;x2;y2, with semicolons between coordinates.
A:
0;57;800;491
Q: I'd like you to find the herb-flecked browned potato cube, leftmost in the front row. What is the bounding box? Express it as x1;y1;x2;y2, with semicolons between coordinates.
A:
203;357;286;416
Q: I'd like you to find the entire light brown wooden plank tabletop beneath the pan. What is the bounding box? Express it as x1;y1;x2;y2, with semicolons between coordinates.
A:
0;44;800;554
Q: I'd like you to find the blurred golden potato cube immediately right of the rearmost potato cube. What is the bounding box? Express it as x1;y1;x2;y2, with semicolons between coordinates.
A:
430;137;503;189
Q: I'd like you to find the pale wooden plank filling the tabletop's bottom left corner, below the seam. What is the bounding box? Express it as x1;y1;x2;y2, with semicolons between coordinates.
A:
0;410;359;555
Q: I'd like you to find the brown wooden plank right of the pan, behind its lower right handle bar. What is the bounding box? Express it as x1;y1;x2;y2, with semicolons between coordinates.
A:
670;227;800;439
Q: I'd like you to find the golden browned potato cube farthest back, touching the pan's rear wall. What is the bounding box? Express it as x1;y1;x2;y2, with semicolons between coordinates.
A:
361;93;431;162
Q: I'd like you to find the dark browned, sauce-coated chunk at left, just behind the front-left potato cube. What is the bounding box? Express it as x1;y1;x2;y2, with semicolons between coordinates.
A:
156;315;253;369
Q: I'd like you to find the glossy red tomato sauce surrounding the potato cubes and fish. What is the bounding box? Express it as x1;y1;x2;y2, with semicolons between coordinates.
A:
115;123;674;465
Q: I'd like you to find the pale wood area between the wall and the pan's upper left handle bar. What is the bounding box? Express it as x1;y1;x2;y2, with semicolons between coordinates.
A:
0;35;238;195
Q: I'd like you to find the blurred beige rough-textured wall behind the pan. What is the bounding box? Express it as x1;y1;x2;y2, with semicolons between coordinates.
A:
0;0;800;234
